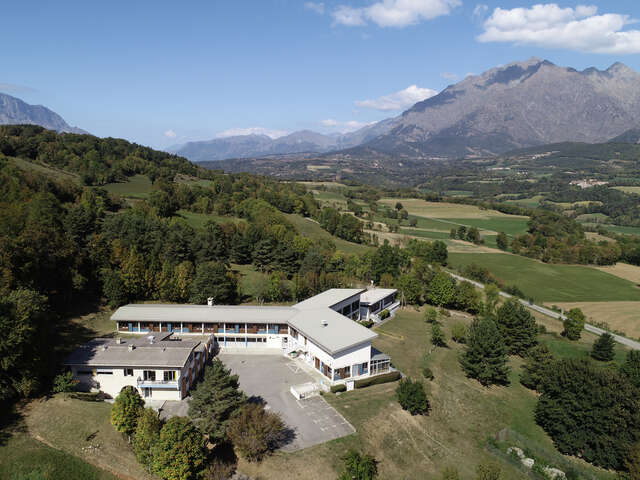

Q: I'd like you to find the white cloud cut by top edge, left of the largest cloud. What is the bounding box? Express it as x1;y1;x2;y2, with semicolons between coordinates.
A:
331;0;462;28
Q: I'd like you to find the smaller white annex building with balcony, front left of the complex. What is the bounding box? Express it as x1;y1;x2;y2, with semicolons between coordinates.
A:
65;333;214;400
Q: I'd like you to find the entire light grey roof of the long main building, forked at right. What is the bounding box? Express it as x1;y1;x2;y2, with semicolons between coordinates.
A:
111;288;378;355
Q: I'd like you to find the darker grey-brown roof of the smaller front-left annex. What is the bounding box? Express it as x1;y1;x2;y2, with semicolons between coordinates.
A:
64;338;202;368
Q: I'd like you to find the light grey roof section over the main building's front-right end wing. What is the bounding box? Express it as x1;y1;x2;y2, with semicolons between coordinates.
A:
289;308;378;355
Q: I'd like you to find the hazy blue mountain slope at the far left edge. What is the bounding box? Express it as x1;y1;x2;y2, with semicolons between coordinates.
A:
0;93;87;133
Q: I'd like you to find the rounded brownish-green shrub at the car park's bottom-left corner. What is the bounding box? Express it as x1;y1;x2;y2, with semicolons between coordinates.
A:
228;403;285;461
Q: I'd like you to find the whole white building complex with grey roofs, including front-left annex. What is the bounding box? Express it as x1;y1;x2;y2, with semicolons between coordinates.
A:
66;289;395;399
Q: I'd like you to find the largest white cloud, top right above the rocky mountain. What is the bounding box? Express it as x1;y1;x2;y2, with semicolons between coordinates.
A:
477;3;640;54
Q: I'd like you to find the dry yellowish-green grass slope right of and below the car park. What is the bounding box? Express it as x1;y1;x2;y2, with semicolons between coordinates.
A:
240;308;625;480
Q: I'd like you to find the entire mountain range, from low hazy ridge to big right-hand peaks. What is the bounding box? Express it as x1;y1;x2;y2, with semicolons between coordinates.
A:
171;58;640;161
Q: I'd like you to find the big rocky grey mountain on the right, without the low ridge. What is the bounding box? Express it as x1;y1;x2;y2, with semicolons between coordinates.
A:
366;58;640;157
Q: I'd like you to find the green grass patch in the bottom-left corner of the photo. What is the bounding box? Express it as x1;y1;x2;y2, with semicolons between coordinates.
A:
0;432;117;480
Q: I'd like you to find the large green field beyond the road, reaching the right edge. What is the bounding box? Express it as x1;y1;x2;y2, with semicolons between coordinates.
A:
449;253;640;302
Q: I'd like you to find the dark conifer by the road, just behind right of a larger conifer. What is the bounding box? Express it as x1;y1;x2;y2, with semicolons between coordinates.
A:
496;298;538;356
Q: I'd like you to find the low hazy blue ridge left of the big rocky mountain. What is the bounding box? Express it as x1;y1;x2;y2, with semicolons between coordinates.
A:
167;120;390;162
